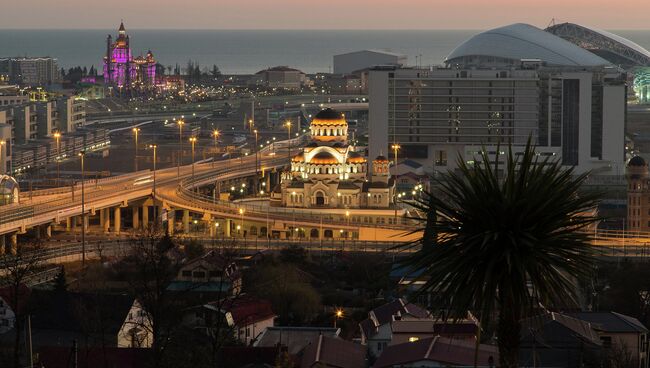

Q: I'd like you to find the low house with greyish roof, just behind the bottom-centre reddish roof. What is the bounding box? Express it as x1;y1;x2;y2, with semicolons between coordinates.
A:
253;326;341;355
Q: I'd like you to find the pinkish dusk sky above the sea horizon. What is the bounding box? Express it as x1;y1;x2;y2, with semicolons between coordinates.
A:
5;0;650;30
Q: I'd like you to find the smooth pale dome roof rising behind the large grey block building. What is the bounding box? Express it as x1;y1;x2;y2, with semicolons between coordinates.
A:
446;23;610;66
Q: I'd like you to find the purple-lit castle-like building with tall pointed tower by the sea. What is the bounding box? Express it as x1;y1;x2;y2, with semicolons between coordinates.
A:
104;23;156;90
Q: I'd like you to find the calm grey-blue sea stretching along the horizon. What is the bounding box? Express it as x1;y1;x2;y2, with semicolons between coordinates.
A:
0;29;650;74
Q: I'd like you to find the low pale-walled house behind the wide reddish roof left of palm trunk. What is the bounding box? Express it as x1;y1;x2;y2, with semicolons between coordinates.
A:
389;318;479;345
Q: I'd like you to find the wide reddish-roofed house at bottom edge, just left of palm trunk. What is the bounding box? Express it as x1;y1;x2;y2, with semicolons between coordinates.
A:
373;336;499;368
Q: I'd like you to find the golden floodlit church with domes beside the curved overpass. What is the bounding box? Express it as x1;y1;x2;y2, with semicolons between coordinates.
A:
271;108;394;208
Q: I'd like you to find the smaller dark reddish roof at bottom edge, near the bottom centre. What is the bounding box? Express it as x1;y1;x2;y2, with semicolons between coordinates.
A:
300;335;366;368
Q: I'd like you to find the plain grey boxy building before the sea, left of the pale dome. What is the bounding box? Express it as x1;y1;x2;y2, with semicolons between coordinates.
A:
334;50;408;74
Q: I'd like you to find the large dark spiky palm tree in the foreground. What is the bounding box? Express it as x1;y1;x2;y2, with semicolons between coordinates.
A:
404;140;598;368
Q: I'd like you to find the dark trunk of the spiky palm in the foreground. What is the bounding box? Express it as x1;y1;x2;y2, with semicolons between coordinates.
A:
497;287;521;368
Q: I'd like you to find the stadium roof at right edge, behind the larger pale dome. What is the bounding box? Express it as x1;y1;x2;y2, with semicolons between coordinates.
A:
546;23;650;67
